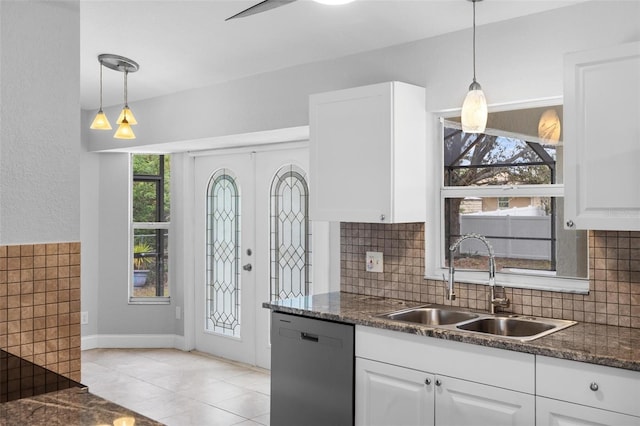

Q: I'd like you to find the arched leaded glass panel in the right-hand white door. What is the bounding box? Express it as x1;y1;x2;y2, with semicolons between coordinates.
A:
270;165;311;300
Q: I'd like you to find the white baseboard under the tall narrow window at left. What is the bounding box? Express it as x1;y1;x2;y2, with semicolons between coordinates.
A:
80;334;193;351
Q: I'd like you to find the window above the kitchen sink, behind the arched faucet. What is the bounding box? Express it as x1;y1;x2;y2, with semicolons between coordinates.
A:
427;107;588;291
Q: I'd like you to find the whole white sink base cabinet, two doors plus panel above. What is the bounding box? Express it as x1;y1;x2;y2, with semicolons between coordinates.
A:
355;327;535;426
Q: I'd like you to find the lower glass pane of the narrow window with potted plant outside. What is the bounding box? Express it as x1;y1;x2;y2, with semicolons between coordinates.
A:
131;229;169;297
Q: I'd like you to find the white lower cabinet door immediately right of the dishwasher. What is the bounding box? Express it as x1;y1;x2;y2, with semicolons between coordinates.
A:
355;358;434;426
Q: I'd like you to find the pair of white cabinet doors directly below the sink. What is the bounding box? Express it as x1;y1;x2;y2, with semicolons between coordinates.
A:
355;358;534;426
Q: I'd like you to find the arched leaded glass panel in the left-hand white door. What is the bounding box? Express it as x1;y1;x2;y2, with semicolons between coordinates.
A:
206;169;240;337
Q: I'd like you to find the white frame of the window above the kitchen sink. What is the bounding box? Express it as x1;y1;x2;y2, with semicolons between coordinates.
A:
425;102;589;294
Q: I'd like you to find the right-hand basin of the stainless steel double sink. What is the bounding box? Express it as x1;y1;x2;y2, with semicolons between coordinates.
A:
456;316;575;341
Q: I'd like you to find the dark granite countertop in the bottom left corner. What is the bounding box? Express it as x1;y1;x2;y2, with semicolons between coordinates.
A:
0;387;162;426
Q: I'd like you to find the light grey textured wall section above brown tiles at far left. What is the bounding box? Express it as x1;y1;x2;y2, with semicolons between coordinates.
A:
0;0;80;245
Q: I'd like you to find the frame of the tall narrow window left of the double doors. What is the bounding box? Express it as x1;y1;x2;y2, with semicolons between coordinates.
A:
127;153;172;305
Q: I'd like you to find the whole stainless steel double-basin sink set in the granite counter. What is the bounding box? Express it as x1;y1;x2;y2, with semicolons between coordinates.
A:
379;305;576;342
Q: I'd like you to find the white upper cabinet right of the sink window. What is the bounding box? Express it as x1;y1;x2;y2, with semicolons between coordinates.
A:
563;43;640;231
